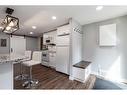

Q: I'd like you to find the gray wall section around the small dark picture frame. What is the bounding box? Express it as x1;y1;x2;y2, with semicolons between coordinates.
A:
0;32;10;54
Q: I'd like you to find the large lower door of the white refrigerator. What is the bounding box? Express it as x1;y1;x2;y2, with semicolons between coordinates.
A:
56;47;69;74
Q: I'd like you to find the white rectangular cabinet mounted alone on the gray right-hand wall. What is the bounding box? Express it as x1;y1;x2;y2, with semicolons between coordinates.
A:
99;24;116;46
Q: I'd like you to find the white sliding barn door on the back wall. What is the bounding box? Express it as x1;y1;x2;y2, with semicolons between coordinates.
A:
10;36;26;55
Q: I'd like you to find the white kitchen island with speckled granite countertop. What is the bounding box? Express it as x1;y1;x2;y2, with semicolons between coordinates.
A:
0;54;26;89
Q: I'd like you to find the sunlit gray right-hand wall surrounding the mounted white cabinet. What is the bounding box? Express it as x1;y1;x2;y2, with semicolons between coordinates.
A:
83;16;127;80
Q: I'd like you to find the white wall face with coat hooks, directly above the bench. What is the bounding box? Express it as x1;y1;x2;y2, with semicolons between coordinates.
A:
71;19;82;65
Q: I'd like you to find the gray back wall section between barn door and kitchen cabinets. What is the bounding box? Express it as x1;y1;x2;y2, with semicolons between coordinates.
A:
26;37;39;51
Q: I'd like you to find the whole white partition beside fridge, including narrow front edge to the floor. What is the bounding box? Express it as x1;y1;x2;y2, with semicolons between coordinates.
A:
69;19;82;79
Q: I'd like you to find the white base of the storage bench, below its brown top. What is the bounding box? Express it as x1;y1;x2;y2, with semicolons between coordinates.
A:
72;65;91;82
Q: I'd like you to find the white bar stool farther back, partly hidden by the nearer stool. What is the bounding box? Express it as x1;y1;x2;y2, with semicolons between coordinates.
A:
15;50;32;80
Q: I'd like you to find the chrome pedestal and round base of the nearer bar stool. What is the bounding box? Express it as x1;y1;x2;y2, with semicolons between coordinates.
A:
22;66;39;88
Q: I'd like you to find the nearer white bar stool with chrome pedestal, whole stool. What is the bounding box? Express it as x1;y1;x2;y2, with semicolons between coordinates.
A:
22;51;42;88
